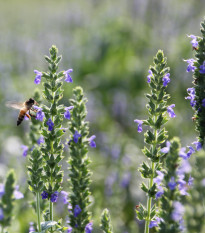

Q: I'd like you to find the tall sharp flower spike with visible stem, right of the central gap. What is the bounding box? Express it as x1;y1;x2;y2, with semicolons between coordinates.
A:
135;50;176;233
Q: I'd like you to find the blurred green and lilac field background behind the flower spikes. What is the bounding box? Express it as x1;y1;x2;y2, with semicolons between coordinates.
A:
0;0;204;233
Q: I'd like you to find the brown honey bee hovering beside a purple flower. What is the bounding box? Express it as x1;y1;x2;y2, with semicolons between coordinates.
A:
6;98;38;126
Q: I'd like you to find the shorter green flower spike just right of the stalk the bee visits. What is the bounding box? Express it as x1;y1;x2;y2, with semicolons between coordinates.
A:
68;87;96;233
